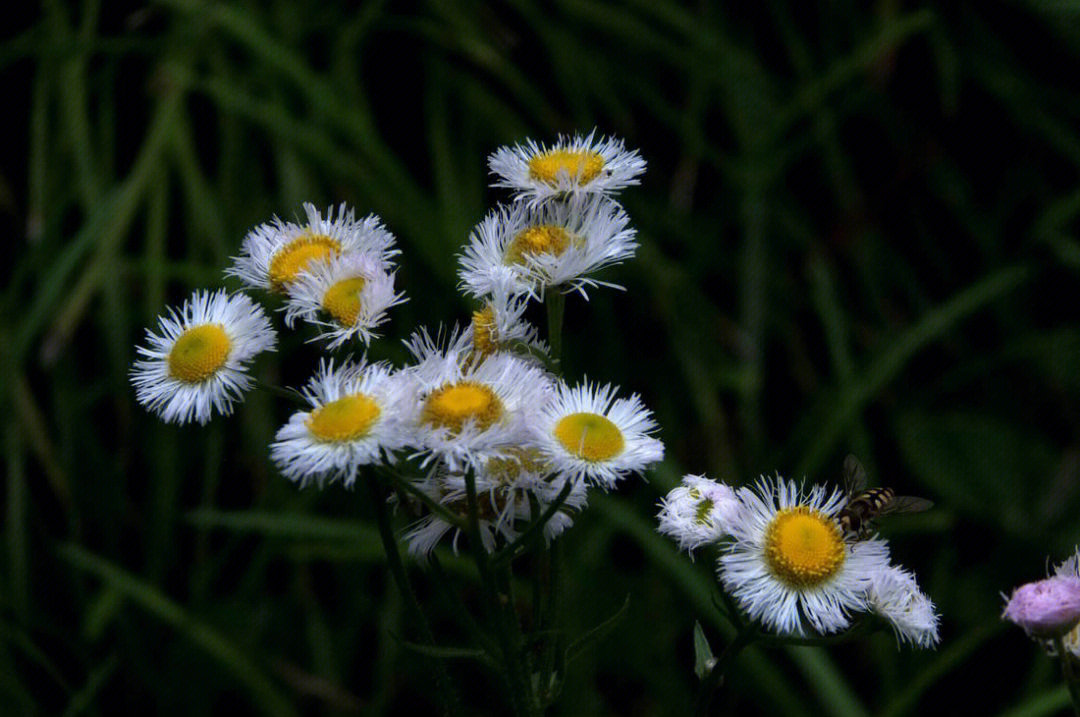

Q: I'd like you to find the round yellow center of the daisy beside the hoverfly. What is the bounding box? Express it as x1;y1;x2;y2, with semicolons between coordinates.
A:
765;505;847;589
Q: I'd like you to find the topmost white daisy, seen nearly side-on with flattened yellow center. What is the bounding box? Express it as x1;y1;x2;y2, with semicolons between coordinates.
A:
487;130;645;203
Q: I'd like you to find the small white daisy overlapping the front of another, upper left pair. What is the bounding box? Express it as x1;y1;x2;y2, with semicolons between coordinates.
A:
285;253;406;349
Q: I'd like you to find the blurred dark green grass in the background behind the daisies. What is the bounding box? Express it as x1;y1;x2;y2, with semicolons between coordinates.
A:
6;0;1080;716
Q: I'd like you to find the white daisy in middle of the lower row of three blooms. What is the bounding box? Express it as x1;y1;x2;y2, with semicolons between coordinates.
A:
405;333;552;472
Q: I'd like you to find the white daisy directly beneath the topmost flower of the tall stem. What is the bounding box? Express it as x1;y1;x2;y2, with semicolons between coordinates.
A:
458;197;637;298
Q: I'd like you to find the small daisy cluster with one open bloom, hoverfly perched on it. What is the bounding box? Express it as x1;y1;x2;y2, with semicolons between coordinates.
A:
658;475;939;648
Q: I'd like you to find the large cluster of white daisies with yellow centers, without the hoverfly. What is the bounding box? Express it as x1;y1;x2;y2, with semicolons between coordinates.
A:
132;134;663;556
